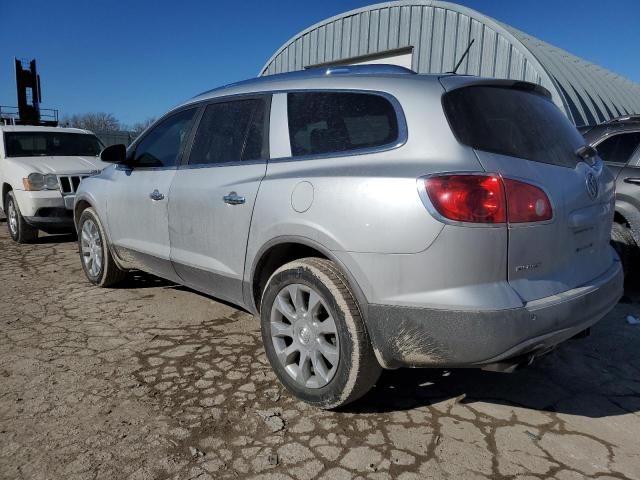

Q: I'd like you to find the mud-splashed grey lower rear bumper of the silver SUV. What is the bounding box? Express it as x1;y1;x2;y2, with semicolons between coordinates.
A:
368;261;623;368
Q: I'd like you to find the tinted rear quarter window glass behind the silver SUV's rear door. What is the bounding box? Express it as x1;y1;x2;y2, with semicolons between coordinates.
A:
287;92;398;157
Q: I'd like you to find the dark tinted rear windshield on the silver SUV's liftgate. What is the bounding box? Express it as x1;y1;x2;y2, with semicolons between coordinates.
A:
443;86;585;168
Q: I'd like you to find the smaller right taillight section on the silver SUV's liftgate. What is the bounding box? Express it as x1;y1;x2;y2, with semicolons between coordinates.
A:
504;178;553;223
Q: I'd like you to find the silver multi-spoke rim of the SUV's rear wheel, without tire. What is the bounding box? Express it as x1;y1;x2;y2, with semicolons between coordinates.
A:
270;284;340;388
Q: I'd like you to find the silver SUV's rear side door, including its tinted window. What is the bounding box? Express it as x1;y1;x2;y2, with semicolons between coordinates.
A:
169;96;270;303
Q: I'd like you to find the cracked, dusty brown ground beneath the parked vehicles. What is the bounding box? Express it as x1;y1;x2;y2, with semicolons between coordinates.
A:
0;223;640;480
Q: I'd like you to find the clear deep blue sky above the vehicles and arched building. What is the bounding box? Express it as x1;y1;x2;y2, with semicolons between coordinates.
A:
0;0;640;124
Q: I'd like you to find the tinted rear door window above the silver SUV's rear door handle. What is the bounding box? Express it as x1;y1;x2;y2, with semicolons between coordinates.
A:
189;99;266;165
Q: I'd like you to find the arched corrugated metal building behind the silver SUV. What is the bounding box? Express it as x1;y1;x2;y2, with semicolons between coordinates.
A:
260;0;640;126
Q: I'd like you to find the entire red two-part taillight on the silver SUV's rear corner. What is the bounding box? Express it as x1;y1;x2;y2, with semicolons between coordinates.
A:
423;175;553;223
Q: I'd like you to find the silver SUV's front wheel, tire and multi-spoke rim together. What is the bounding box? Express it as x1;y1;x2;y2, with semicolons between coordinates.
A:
78;207;126;287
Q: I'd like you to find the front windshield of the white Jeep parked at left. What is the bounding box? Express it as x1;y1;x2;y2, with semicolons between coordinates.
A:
4;132;102;157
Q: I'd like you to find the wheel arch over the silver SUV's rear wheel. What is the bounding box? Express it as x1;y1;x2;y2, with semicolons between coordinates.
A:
250;236;368;323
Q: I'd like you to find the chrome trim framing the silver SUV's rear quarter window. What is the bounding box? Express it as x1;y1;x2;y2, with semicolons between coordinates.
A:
270;88;409;163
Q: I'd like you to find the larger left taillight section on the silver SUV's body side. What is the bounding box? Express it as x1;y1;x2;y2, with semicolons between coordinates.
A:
424;175;507;223
